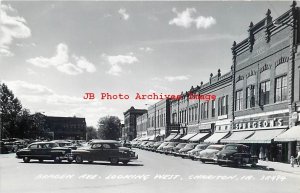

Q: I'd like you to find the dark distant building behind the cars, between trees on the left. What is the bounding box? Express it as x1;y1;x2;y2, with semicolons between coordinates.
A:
46;116;86;139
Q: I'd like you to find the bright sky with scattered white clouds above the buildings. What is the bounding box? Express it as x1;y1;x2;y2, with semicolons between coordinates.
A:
0;1;292;126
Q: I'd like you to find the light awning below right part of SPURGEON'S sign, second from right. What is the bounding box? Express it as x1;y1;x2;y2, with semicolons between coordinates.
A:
244;129;285;143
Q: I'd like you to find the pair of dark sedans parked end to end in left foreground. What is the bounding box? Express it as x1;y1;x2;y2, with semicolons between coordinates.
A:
16;140;138;165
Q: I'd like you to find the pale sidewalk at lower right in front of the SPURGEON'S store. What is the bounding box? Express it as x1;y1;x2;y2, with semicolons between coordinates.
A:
257;160;300;175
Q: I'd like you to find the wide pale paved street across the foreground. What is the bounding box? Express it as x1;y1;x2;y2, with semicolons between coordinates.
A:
0;149;300;193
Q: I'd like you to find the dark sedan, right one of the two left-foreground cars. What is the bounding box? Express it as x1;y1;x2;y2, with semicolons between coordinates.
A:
72;140;138;165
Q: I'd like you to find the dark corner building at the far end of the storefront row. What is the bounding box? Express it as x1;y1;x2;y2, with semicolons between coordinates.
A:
122;107;147;140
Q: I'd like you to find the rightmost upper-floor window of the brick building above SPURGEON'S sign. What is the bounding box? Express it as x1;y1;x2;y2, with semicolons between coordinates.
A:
275;76;288;102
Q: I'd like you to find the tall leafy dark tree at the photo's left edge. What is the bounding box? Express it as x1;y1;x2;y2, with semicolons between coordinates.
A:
0;83;22;139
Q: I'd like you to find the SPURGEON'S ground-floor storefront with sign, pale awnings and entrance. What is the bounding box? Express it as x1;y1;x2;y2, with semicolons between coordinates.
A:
226;113;289;162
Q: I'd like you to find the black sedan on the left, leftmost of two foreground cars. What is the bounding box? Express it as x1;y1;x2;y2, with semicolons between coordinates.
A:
16;142;73;163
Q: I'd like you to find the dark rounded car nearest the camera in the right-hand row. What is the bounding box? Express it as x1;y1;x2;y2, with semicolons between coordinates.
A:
215;144;258;166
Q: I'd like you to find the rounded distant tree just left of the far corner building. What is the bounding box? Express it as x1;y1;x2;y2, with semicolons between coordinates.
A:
98;116;121;140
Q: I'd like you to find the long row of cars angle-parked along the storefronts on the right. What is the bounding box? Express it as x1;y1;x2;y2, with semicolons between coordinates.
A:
131;141;258;166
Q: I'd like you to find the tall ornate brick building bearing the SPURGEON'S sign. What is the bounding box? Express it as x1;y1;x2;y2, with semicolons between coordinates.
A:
221;3;300;162
